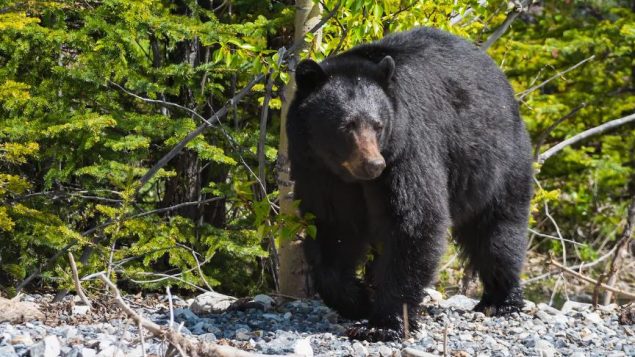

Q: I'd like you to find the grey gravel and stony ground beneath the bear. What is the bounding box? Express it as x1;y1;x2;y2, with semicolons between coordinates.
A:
0;291;635;357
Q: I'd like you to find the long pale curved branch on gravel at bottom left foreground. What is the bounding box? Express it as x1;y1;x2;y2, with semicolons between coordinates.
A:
95;272;290;357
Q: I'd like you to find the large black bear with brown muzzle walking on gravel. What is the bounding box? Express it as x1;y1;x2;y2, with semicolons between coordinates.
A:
287;28;532;340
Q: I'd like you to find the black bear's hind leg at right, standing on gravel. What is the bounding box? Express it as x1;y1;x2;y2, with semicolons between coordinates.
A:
455;203;529;315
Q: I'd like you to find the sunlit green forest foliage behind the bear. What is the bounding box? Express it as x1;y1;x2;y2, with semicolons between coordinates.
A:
0;0;635;302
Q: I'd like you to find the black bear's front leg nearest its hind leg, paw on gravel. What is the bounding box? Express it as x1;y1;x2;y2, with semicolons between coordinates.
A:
348;169;450;341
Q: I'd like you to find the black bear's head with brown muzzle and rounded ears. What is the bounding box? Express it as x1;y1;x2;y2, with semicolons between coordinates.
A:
288;56;395;182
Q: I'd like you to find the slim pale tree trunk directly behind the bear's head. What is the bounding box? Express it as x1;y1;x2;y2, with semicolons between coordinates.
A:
278;0;321;297
